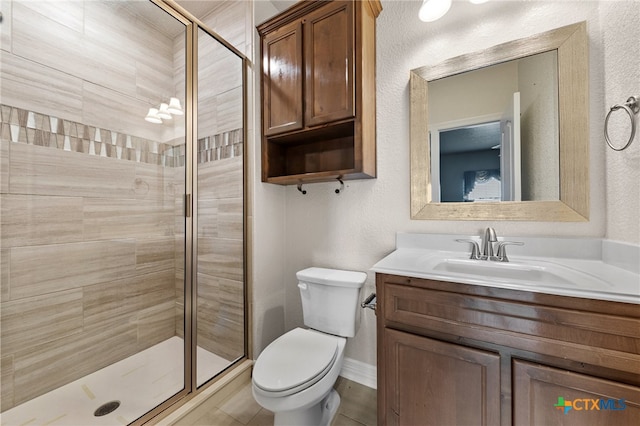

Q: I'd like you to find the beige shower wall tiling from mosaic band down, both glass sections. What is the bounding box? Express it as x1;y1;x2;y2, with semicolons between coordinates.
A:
0;105;244;410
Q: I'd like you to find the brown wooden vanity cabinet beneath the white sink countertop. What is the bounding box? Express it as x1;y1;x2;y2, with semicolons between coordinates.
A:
376;274;640;426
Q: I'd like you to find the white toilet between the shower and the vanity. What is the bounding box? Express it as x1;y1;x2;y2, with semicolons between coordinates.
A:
252;267;367;426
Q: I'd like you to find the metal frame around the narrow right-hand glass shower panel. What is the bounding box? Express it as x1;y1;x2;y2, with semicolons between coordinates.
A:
131;0;251;425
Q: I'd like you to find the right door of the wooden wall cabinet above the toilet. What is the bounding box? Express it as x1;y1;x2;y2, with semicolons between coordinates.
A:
303;1;355;127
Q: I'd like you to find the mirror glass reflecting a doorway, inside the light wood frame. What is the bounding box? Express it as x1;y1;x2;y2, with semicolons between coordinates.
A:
428;50;560;202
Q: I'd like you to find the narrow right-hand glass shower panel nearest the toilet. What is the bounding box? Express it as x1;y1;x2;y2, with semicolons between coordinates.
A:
194;28;245;386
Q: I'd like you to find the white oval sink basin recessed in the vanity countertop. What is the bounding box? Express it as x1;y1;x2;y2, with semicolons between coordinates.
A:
422;256;611;289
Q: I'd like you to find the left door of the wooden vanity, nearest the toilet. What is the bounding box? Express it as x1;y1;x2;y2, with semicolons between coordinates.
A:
383;329;500;426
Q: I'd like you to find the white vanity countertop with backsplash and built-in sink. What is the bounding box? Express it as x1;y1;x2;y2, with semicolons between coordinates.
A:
372;234;640;304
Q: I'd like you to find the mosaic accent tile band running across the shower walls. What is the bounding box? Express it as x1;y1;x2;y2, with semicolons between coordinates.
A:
0;104;243;167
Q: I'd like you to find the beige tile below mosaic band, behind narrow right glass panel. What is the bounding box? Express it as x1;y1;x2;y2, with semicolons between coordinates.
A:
197;157;244;360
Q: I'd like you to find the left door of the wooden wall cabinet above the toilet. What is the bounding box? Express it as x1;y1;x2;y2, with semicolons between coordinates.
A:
262;21;303;135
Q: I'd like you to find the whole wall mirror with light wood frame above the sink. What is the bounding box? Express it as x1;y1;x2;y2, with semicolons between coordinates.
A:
410;22;589;222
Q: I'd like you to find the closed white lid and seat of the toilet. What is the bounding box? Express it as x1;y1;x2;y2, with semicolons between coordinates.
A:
253;328;340;396
